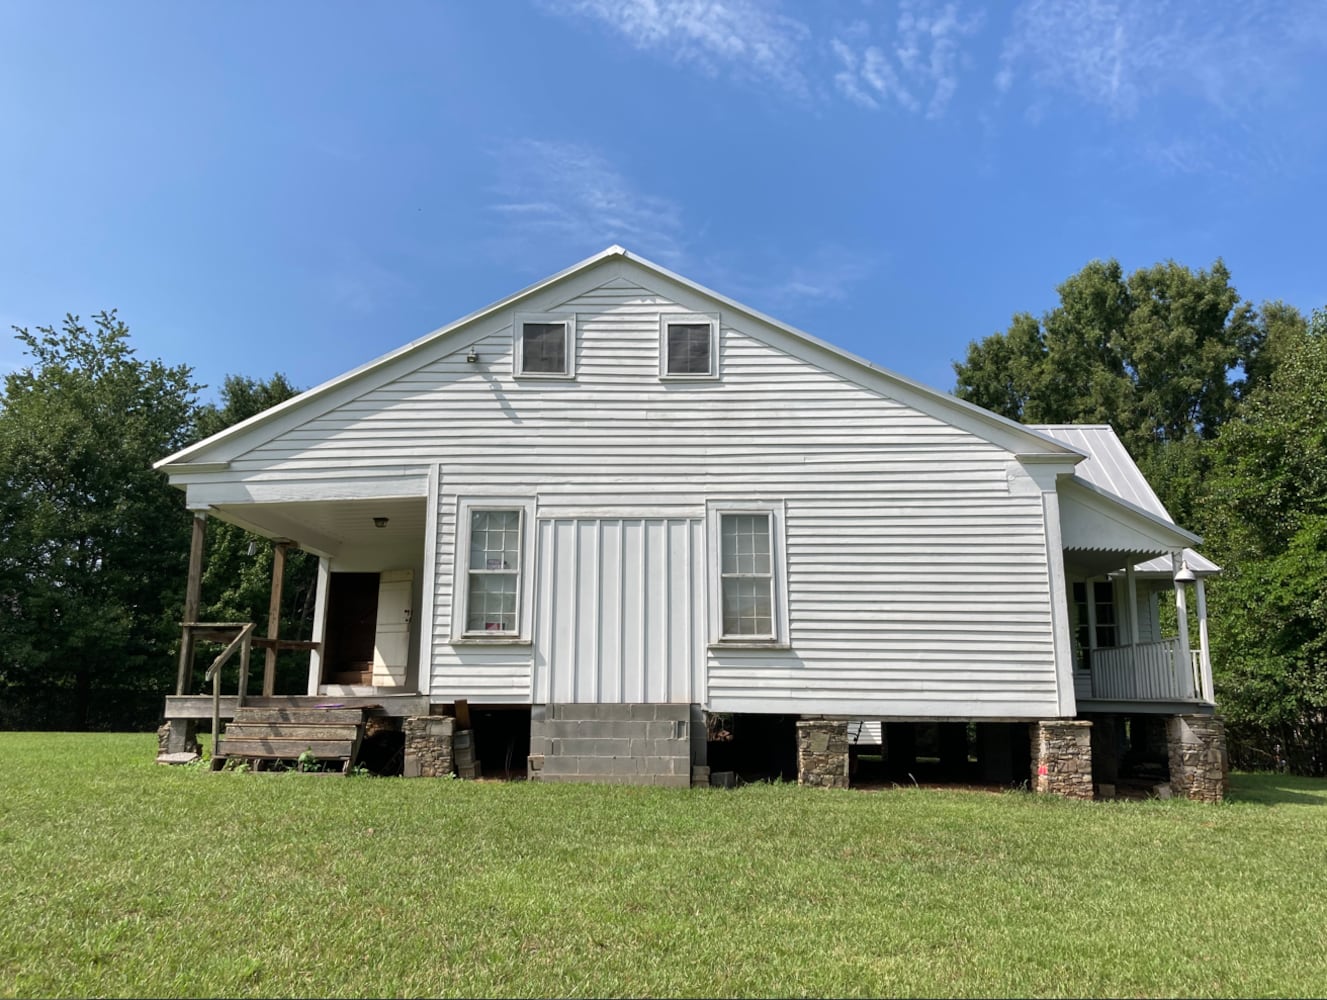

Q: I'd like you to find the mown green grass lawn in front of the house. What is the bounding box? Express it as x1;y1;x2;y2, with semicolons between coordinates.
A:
0;733;1327;996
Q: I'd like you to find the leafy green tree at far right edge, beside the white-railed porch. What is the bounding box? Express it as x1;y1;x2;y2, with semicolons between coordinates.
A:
1205;309;1327;775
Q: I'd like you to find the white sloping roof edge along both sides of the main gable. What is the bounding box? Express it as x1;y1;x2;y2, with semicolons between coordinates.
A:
154;245;1083;472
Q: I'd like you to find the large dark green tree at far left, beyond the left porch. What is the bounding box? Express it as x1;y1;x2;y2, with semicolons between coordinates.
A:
0;310;198;728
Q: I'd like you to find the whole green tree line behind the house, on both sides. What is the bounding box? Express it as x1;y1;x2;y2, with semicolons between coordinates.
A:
0;269;1327;775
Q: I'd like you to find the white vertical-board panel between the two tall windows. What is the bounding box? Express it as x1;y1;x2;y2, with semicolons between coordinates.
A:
535;519;705;704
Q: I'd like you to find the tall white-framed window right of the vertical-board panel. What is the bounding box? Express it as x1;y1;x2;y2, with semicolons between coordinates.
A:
710;501;788;645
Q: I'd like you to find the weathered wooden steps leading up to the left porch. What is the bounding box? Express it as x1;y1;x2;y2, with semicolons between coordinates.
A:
212;706;372;773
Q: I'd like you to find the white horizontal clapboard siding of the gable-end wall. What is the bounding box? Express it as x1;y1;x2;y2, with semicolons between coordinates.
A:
209;279;1056;718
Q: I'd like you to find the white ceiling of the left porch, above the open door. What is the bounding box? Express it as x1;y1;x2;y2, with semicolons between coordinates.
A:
210;496;427;556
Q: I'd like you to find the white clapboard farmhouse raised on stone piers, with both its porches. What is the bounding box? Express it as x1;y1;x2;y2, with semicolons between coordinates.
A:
158;247;1225;798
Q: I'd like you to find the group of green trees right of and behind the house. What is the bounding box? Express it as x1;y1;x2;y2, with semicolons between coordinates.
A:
954;260;1327;775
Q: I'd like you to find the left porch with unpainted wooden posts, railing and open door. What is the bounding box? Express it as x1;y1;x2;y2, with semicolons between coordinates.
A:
161;496;429;756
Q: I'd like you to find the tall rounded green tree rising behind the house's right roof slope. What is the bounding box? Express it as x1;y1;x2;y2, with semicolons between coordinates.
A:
954;260;1273;458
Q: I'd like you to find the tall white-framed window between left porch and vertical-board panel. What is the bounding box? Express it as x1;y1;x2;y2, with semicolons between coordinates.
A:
454;500;529;639
